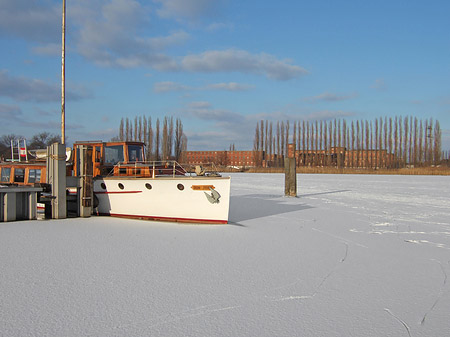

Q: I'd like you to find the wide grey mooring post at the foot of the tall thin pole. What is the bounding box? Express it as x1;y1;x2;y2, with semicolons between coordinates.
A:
47;143;67;219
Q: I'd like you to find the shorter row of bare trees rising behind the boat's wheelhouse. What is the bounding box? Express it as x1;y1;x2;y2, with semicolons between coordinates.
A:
118;116;187;160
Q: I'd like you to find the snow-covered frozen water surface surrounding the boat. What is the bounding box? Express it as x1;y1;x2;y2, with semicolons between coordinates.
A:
0;174;450;337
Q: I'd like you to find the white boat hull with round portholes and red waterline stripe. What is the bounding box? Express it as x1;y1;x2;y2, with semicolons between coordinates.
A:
94;176;230;224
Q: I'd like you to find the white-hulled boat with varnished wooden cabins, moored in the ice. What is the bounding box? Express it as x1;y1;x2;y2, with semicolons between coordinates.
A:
0;141;230;224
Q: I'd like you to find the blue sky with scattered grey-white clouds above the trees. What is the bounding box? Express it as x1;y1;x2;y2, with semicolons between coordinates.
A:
0;0;450;150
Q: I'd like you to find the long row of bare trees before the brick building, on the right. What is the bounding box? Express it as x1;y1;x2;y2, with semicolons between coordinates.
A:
253;116;448;168
